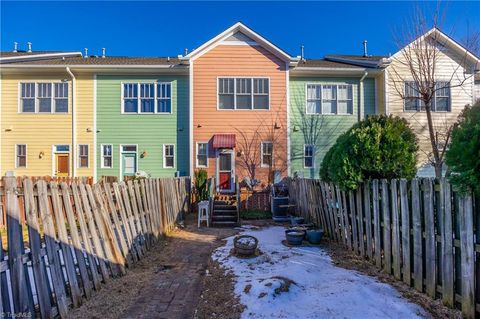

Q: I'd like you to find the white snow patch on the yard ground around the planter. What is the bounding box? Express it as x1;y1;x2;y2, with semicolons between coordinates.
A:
212;227;429;319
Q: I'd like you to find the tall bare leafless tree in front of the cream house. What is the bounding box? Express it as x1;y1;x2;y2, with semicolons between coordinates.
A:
389;8;474;178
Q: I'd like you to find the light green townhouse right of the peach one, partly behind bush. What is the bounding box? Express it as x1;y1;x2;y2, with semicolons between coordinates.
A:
289;61;376;178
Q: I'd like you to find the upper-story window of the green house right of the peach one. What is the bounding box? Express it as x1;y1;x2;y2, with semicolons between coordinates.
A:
306;84;353;114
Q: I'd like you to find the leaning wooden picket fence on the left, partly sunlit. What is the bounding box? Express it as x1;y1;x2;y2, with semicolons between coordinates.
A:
0;177;190;318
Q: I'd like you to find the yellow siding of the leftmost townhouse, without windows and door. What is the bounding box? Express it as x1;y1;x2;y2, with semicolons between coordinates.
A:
0;72;93;176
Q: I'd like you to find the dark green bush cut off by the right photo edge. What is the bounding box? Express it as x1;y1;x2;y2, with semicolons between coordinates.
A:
446;103;480;195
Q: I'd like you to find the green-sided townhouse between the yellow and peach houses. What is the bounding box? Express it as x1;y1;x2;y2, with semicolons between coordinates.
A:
96;75;190;179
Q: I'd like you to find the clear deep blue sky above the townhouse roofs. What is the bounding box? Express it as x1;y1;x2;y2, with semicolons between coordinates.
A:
0;1;480;58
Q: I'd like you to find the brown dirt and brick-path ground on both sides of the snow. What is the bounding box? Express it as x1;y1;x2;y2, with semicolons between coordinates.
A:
70;220;461;319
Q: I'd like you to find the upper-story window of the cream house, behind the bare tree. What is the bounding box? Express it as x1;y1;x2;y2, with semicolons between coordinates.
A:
404;81;452;112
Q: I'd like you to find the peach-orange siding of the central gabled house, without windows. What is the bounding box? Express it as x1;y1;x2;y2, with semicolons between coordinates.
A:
192;45;287;182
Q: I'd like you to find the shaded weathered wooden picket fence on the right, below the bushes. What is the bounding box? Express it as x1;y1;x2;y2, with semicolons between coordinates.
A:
289;178;480;318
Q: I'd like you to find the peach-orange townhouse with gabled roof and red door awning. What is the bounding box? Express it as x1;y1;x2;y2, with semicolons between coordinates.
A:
184;23;295;192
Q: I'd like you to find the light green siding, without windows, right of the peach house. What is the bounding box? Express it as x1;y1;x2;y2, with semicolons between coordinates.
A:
290;77;375;178
